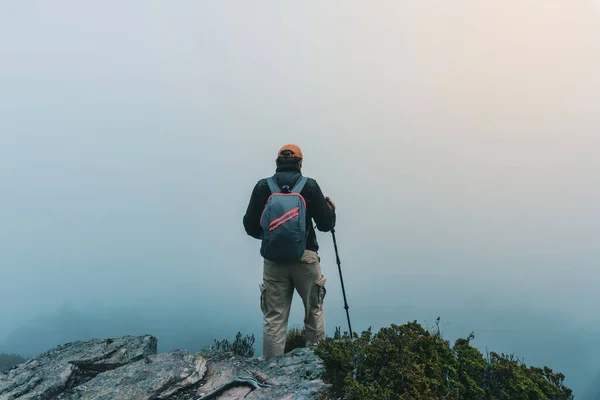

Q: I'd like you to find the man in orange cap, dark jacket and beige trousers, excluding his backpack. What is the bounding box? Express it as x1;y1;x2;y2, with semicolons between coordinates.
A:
243;144;336;360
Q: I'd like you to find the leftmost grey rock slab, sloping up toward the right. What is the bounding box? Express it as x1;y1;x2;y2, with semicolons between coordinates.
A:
0;336;157;400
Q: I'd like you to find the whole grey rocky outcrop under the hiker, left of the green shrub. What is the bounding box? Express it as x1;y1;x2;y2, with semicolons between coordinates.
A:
0;336;328;400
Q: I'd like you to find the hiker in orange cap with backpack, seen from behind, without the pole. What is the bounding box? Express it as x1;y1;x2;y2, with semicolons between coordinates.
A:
243;144;335;360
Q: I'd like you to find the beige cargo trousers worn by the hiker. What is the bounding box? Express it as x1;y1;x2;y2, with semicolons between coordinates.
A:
260;250;327;360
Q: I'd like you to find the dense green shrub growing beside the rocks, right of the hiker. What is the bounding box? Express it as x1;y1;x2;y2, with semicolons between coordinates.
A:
315;318;573;400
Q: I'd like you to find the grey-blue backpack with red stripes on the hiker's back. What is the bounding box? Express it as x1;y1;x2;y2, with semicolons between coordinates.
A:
260;176;308;263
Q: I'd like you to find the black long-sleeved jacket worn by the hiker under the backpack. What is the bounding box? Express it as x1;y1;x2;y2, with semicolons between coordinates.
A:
243;165;335;251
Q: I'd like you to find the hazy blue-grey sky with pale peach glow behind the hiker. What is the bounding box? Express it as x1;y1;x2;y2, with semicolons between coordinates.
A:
0;0;600;395
